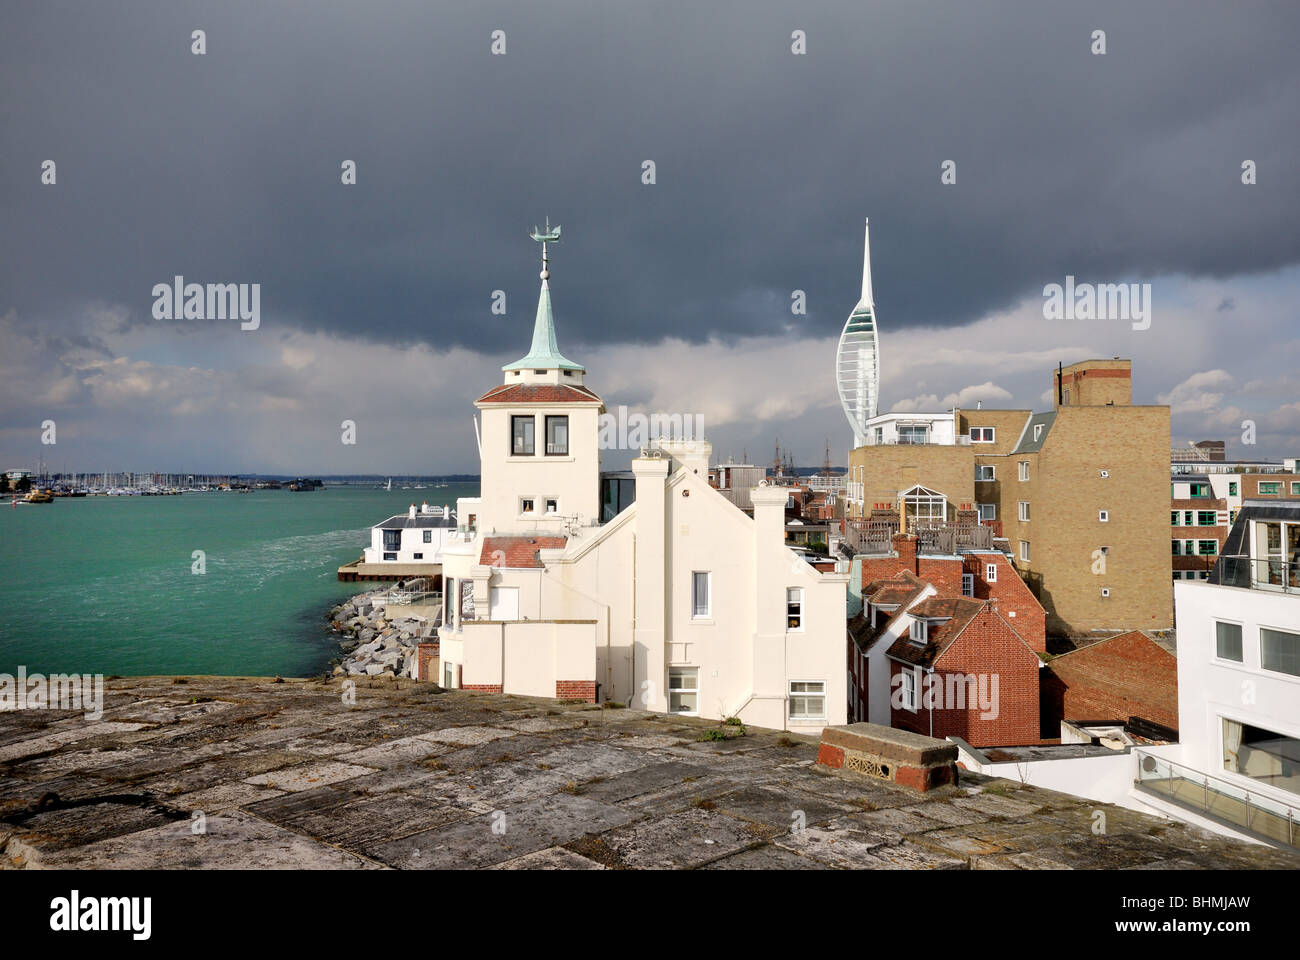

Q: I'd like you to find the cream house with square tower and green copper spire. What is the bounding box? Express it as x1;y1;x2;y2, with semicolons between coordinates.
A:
437;223;848;732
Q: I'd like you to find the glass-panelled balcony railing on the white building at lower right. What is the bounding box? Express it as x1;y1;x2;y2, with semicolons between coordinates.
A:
1134;749;1300;847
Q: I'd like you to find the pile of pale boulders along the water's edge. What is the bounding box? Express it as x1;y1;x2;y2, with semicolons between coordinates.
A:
329;587;433;676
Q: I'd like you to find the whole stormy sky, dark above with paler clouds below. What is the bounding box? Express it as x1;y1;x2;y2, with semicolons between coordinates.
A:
0;0;1300;473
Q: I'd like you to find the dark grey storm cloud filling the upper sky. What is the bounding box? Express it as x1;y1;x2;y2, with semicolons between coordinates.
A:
0;0;1300;350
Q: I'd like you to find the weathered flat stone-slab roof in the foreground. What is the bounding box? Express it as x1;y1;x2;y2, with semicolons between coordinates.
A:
0;678;1300;869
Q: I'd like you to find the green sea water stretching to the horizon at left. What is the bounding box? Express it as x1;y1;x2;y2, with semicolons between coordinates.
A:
0;484;478;676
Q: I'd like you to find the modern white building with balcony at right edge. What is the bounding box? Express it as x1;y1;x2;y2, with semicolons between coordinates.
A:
961;500;1300;848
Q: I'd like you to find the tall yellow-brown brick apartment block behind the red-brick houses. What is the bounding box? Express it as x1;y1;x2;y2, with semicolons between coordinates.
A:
850;358;1173;635
